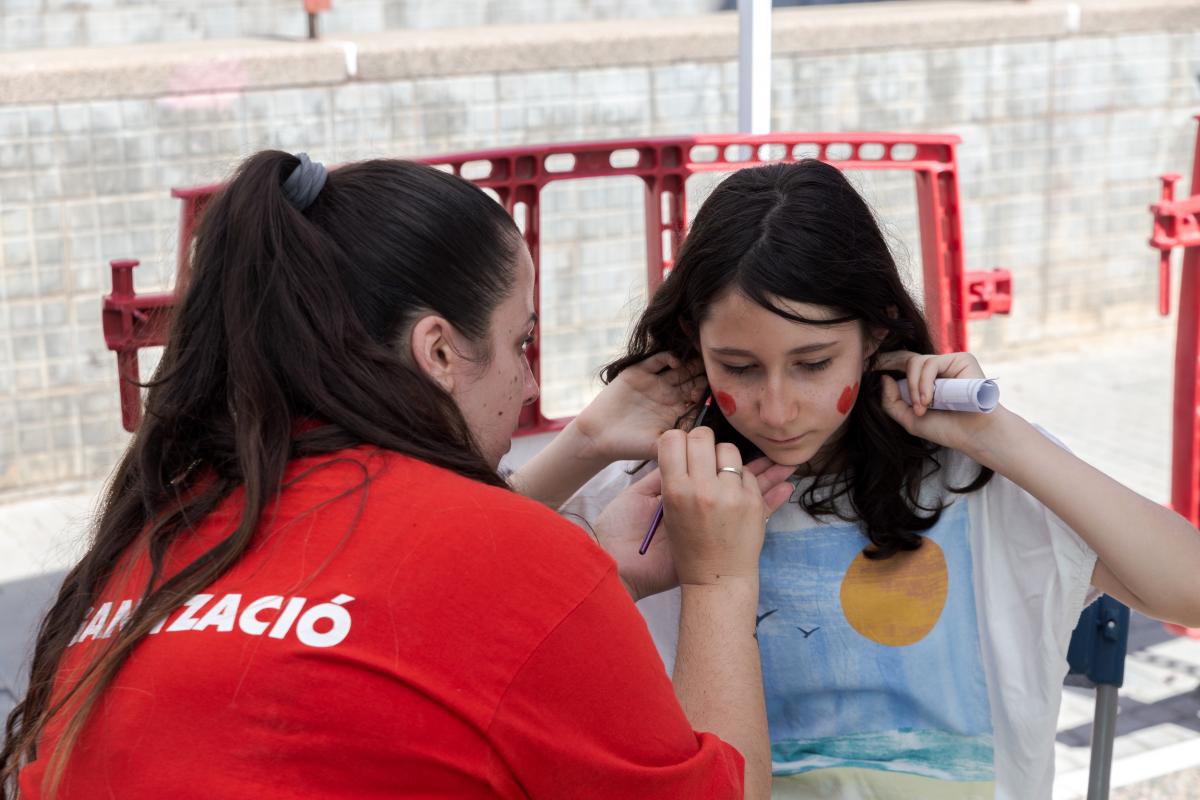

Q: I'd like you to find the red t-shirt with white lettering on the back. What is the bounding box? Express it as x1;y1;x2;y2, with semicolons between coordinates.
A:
20;449;743;800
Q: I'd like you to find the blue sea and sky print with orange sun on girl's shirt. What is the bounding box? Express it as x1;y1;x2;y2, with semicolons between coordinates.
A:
757;499;995;799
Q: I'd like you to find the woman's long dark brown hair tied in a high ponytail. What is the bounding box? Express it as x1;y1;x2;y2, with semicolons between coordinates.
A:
0;151;520;796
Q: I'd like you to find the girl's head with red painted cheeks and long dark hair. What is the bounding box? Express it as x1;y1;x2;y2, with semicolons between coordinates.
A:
605;161;937;554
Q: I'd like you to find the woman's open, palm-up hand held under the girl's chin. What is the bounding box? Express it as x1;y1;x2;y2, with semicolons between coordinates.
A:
593;458;794;601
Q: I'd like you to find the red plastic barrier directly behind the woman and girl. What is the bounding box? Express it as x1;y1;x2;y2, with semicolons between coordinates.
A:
103;133;1012;433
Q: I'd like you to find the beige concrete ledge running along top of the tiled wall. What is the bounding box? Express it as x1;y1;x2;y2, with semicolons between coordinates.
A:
0;0;1200;104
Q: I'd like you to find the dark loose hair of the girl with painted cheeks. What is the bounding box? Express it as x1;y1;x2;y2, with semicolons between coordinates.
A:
602;160;992;558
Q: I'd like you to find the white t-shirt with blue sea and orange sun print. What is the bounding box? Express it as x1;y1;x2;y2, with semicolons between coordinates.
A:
564;438;1096;800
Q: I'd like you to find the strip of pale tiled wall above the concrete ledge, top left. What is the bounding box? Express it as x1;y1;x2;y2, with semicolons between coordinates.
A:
0;0;730;52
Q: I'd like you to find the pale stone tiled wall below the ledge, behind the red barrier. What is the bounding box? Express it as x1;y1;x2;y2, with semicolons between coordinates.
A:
0;6;1200;492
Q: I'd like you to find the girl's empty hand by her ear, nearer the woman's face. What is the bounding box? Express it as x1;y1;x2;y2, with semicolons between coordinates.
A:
572;353;708;463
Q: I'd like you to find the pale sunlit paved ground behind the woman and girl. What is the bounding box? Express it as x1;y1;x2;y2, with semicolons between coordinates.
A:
0;326;1200;800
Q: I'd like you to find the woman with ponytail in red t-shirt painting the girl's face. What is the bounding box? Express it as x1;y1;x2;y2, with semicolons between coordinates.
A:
2;151;790;800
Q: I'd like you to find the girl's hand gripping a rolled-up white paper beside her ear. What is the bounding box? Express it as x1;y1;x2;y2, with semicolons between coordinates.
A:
875;350;1003;455
